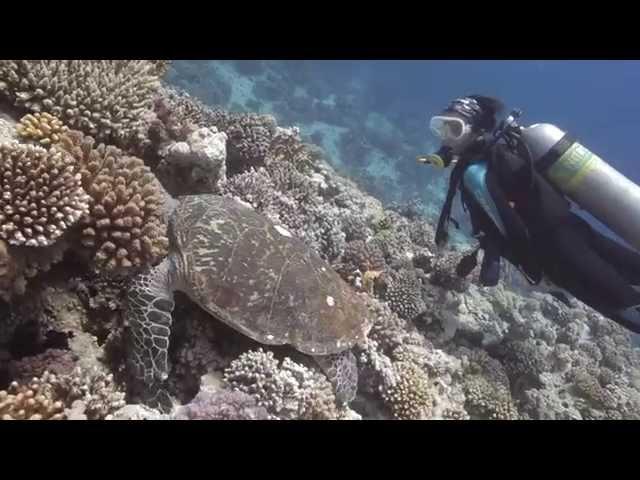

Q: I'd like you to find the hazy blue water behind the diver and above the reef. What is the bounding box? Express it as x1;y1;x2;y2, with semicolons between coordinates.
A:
169;60;640;240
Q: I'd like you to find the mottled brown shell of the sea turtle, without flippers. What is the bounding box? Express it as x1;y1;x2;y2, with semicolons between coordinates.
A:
171;195;369;355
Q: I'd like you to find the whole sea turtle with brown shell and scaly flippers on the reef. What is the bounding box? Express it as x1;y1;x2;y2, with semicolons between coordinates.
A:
125;194;370;406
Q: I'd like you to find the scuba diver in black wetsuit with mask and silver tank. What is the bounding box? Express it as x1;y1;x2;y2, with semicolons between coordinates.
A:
418;95;640;333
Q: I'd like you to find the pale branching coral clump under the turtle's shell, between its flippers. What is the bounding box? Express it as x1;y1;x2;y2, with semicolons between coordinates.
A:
224;348;338;420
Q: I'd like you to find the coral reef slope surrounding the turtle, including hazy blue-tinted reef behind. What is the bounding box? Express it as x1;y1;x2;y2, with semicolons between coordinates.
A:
0;60;640;419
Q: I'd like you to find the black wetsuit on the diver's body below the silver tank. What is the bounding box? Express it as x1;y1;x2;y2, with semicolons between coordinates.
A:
452;144;640;333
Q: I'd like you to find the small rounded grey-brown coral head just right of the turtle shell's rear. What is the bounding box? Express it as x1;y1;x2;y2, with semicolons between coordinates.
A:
383;269;427;320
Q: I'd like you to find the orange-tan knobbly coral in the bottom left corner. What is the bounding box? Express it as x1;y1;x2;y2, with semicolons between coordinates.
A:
0;372;65;420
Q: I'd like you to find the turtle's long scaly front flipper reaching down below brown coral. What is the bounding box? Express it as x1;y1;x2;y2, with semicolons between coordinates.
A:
125;259;175;408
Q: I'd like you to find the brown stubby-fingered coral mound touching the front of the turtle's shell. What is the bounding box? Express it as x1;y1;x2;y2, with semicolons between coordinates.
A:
52;131;168;271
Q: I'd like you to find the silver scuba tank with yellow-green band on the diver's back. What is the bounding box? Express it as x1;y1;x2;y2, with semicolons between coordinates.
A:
511;123;640;249
